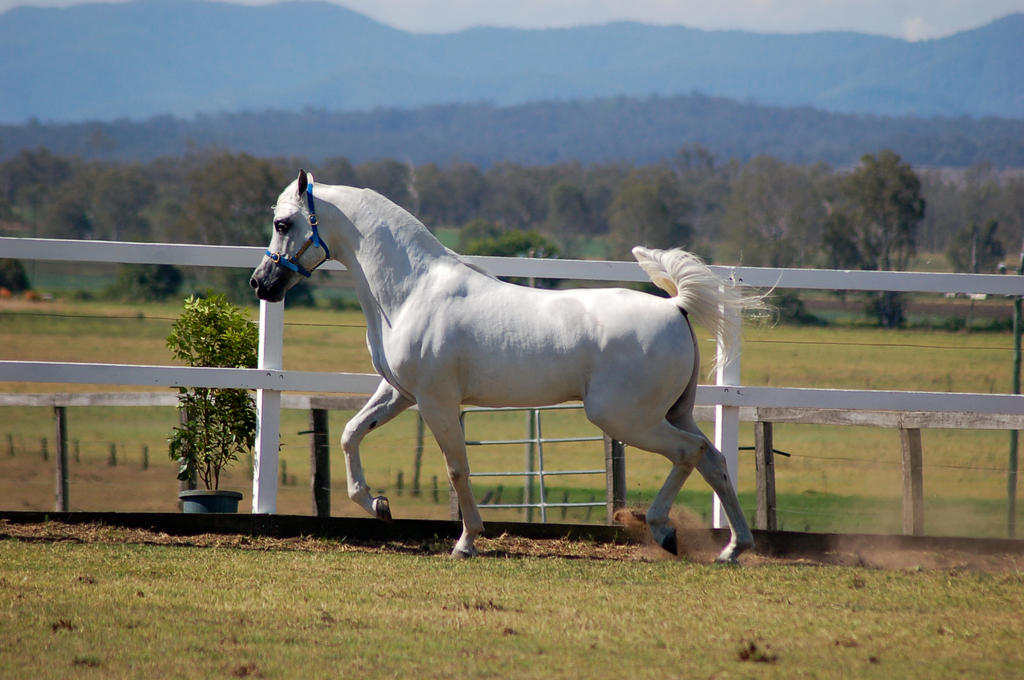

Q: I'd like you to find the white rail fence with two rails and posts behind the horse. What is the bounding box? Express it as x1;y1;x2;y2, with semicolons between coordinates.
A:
0;238;1024;526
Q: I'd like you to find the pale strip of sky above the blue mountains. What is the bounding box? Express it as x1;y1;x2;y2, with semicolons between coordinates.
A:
0;0;1024;41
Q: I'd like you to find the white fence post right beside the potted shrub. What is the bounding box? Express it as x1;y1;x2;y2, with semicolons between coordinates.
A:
252;300;285;513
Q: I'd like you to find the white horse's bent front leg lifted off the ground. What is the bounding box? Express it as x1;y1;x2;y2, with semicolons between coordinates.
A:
341;380;413;521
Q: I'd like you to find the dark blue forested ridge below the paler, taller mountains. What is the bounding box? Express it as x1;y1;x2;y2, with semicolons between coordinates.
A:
6;92;1024;168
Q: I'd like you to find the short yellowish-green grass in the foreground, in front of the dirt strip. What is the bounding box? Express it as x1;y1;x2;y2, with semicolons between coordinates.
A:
0;540;1024;680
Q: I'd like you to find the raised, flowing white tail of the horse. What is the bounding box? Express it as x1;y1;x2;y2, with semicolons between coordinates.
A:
633;246;768;371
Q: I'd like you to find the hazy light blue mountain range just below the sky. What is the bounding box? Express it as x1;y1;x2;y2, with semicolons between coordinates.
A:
0;0;1024;124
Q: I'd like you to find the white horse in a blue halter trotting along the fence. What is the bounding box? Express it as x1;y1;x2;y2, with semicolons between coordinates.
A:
250;171;762;562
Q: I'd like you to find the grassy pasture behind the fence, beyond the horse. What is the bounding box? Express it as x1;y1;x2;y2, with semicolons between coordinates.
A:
0;299;1024;536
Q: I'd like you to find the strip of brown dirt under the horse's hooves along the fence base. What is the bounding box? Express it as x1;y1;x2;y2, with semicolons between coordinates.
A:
0;518;1024;573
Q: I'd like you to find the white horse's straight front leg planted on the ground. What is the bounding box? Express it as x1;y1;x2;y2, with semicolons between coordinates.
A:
420;400;483;558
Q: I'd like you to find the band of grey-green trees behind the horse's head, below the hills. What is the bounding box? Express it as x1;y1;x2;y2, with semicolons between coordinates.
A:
0;145;1024;325
